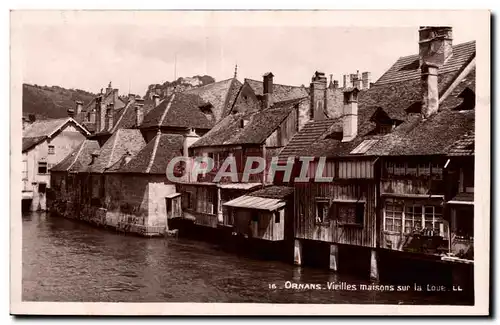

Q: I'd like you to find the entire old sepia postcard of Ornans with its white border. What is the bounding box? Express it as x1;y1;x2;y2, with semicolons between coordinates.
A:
10;10;490;315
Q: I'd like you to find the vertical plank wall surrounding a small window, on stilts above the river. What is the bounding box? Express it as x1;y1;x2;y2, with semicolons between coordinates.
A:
295;180;377;247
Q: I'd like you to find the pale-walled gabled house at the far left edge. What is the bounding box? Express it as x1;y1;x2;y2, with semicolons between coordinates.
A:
22;117;89;211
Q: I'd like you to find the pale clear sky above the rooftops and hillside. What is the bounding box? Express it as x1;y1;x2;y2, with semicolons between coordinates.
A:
16;13;474;95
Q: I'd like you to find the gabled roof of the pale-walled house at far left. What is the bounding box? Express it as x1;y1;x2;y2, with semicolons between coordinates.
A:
22;117;89;152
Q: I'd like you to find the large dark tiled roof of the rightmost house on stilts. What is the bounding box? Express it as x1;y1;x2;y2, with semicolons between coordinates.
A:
280;42;475;159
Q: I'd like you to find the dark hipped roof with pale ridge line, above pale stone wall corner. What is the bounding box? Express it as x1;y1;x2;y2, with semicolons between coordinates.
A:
117;134;184;174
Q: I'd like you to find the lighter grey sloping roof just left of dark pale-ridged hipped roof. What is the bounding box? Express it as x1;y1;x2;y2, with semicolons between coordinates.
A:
88;129;146;173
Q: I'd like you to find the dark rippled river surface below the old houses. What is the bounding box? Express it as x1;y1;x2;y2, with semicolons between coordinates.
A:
22;213;472;305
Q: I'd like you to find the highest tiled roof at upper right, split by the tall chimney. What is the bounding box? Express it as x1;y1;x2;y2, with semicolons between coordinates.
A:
375;41;476;85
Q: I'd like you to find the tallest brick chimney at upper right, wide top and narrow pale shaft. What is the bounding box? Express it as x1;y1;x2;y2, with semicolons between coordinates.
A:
418;26;453;118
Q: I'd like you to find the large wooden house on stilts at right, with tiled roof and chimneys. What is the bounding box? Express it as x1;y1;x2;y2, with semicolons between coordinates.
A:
280;28;475;278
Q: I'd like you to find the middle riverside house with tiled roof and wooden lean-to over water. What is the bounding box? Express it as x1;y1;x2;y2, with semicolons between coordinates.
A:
178;73;309;241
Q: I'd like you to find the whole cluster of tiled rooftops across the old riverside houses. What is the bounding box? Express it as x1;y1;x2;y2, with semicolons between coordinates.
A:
23;29;476;178
